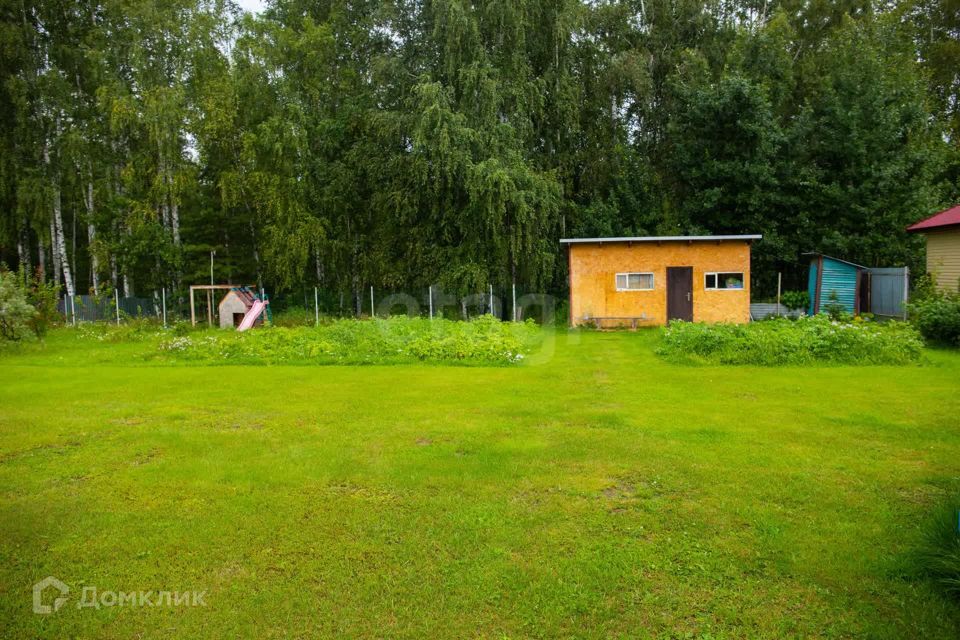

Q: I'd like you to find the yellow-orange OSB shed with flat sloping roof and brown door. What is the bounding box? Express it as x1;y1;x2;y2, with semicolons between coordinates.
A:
560;235;761;327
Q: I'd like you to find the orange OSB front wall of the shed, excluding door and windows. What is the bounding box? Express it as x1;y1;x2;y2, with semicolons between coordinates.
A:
568;241;750;325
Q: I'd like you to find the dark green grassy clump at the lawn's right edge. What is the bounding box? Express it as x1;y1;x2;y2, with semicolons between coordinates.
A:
916;497;960;602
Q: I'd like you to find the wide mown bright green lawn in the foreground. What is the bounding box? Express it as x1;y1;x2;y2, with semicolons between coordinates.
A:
0;331;960;638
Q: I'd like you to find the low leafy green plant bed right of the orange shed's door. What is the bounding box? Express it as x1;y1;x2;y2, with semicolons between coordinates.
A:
657;315;923;366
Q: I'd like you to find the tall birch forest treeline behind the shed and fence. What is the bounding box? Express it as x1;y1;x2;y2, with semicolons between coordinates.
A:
0;0;960;305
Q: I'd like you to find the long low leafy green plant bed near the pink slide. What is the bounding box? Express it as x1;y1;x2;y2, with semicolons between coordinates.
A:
158;316;540;364
